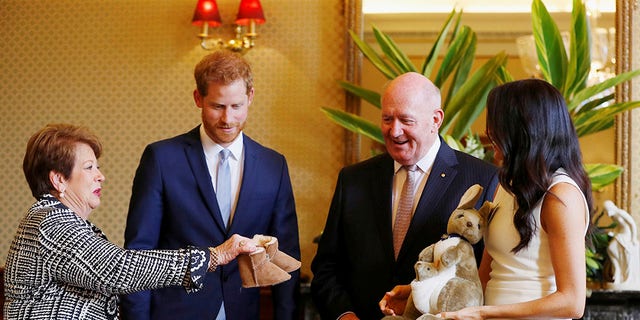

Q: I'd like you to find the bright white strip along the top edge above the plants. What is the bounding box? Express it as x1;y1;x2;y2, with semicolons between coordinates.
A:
362;0;616;14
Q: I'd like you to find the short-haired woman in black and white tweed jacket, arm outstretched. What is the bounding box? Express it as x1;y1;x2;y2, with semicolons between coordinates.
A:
4;124;256;319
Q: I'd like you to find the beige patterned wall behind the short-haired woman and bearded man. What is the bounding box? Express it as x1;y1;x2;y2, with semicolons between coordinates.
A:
0;0;345;275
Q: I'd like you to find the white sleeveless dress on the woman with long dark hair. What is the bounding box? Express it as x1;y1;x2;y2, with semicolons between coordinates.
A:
484;169;589;319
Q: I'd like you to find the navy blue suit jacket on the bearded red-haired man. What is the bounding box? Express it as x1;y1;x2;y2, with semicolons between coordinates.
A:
121;127;300;319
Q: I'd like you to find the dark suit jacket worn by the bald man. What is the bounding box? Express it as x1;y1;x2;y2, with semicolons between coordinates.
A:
311;139;498;319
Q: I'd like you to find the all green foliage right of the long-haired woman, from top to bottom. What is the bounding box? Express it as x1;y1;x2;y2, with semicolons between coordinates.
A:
531;0;640;281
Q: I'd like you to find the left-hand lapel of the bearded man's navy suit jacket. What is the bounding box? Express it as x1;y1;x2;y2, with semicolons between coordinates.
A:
184;127;226;233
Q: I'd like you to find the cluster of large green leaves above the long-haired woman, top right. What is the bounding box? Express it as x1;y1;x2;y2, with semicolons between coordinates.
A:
531;0;640;137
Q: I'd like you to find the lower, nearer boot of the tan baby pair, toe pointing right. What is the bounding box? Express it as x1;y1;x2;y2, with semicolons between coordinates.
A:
238;247;291;288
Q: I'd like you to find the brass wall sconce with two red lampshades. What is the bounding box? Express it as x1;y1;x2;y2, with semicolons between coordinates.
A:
192;0;266;53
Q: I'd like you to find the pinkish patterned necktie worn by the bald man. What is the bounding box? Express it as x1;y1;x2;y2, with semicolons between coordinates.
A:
393;164;418;259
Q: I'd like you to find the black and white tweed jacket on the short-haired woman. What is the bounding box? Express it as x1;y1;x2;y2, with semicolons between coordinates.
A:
4;195;209;319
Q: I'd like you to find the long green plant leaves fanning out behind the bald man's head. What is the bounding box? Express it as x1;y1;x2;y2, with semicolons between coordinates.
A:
322;10;511;157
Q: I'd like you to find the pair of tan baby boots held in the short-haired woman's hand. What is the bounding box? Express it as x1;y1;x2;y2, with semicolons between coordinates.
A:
238;234;300;288
